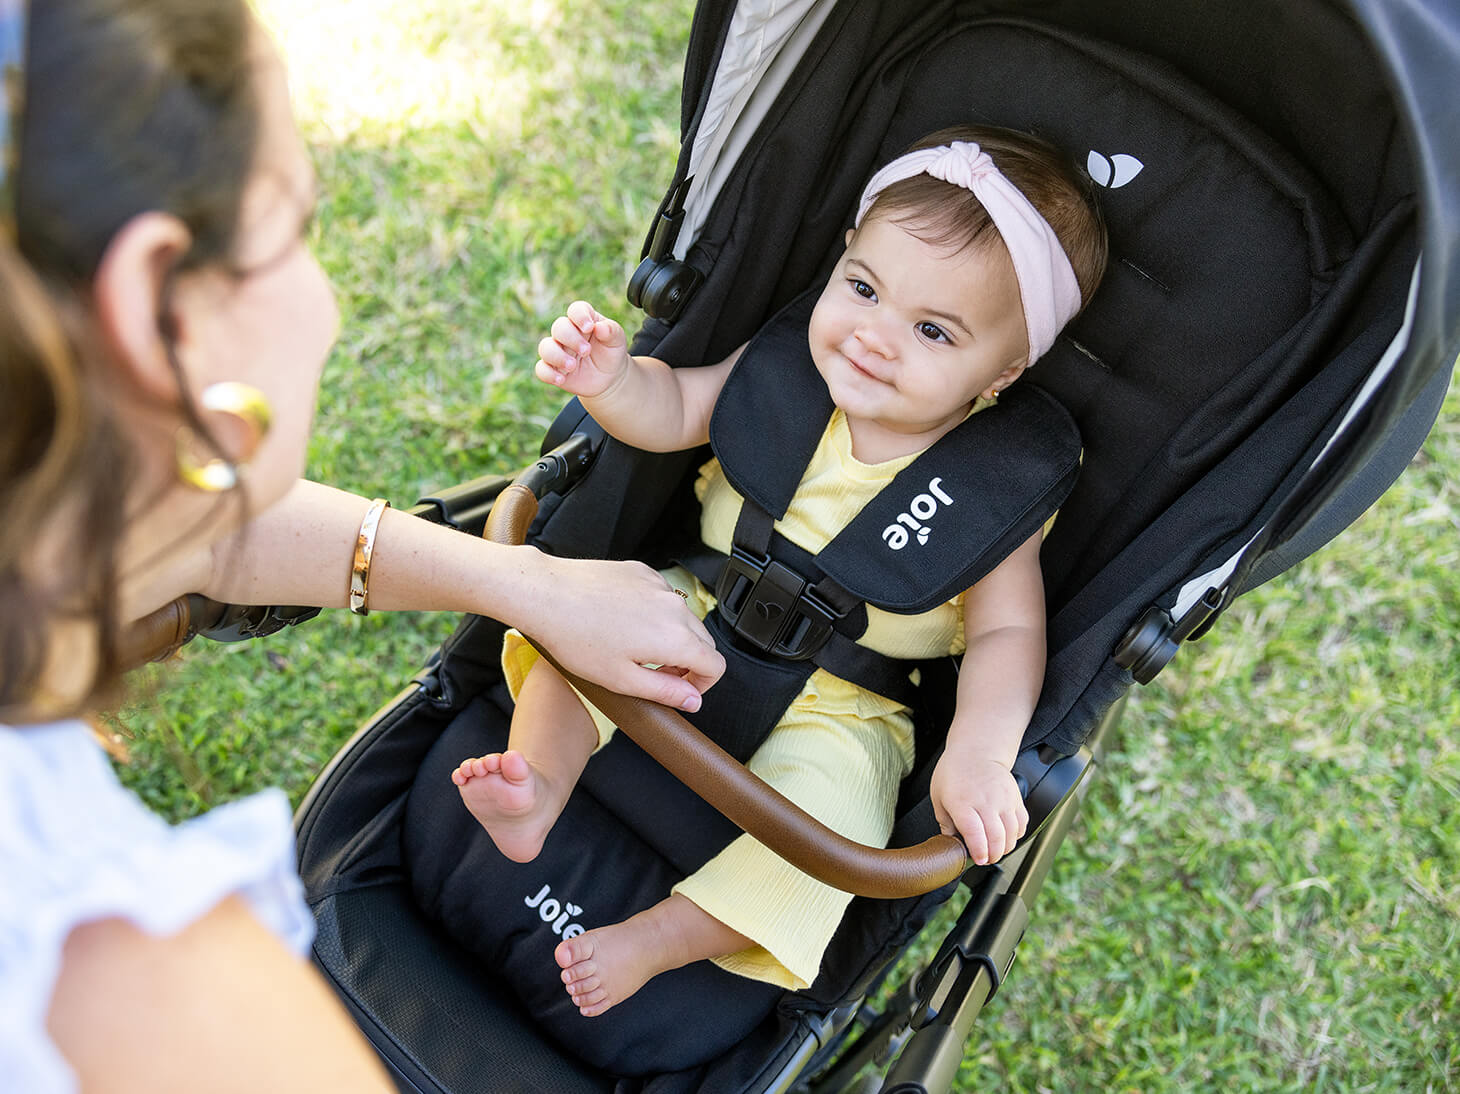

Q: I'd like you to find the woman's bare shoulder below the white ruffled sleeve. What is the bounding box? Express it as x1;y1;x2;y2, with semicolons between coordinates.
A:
48;897;394;1094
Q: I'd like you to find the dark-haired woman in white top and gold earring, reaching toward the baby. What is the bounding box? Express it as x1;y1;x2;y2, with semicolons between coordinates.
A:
0;0;723;1091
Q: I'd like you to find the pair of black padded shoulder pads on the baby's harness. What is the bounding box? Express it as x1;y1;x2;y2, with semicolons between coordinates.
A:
710;292;1080;613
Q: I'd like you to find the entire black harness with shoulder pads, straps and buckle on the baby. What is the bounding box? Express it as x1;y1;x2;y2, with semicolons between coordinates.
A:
679;283;1080;758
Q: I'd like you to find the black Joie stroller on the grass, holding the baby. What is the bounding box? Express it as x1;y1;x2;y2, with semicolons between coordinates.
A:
265;0;1460;1094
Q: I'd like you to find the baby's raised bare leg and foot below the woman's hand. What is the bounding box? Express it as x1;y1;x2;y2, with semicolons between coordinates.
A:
451;660;599;862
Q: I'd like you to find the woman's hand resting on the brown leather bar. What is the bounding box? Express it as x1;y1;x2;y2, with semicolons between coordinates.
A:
510;548;726;711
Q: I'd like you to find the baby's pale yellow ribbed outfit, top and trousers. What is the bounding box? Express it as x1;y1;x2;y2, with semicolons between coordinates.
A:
502;409;964;990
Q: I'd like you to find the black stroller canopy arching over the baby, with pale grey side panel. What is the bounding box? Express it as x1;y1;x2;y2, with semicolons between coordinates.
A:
645;0;1460;739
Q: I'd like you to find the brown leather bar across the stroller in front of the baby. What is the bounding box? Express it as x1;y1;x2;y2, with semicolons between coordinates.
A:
482;483;971;900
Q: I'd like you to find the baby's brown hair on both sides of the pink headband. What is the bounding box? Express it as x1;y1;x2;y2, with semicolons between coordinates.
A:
867;126;1108;308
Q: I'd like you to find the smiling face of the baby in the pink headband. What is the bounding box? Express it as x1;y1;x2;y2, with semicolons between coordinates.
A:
810;216;1029;451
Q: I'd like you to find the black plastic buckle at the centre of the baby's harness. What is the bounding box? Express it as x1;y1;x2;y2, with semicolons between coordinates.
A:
715;548;841;662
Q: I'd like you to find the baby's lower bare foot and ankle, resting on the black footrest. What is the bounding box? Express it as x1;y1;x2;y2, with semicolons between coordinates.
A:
553;892;753;1018
